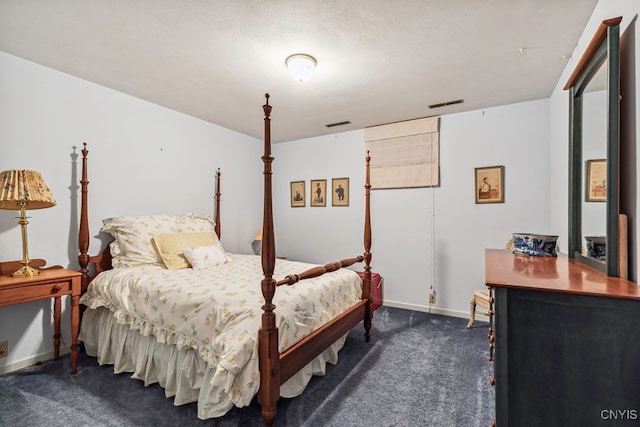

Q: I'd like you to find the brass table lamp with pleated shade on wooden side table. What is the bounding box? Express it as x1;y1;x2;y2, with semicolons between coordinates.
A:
0;170;56;277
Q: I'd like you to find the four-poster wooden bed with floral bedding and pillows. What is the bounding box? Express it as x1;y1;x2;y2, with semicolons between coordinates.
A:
78;94;372;425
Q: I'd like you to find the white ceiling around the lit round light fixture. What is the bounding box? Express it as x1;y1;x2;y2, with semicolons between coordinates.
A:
0;0;597;142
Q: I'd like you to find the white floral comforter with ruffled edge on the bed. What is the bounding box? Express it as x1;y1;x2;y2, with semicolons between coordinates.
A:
80;254;361;414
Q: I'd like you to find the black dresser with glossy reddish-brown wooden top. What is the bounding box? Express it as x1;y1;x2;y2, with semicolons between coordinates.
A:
485;249;640;427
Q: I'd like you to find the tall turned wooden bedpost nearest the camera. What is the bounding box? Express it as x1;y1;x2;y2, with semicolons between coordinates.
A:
258;94;280;426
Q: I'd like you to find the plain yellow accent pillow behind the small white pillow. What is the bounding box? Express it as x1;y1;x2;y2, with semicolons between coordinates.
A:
153;232;219;270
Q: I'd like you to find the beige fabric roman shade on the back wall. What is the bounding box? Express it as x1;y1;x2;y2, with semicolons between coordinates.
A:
364;117;440;189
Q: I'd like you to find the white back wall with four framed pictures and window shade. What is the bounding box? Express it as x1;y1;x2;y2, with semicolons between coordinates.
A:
274;100;550;316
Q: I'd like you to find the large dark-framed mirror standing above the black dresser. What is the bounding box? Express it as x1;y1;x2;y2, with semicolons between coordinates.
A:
564;17;626;277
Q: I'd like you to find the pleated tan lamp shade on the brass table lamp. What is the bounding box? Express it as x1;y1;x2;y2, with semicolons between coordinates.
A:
0;170;56;210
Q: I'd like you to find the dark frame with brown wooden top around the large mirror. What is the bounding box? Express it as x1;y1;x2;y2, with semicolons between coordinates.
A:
564;16;622;277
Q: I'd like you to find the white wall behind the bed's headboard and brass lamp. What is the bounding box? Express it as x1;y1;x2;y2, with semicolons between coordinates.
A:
0;52;262;372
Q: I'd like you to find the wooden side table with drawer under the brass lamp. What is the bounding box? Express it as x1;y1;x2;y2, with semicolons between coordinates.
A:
0;260;82;374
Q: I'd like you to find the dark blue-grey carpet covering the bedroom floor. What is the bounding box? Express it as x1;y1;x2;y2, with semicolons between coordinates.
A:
0;307;495;427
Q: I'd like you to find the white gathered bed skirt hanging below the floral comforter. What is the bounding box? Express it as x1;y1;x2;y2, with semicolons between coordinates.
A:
80;307;347;419
